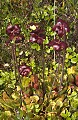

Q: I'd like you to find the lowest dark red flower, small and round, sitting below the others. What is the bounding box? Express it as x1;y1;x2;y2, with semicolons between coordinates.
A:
19;64;31;76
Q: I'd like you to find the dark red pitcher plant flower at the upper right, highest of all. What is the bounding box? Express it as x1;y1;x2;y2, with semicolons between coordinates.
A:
52;19;70;37
